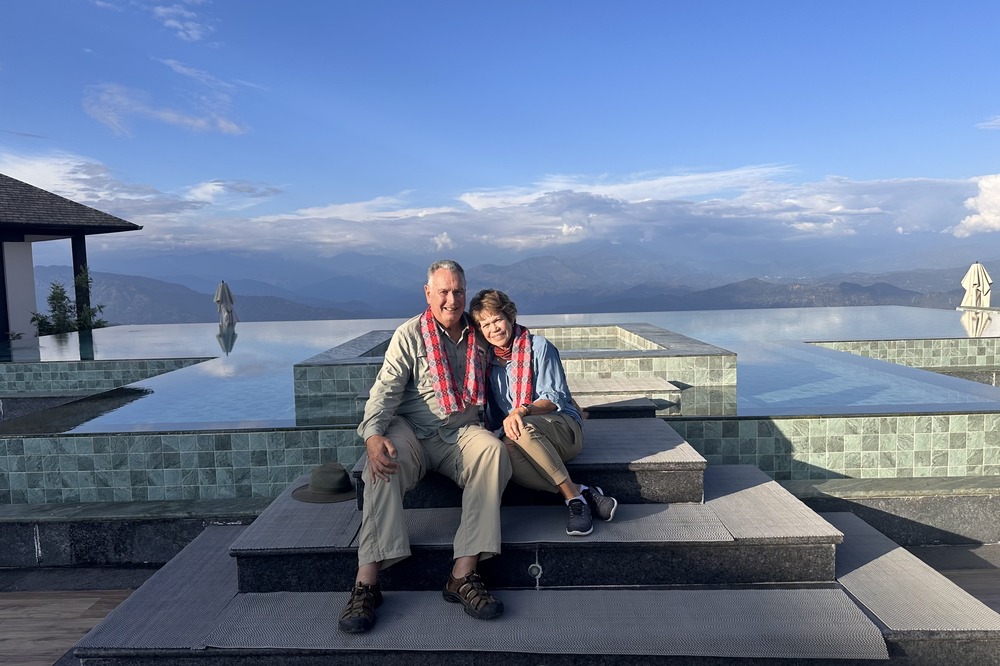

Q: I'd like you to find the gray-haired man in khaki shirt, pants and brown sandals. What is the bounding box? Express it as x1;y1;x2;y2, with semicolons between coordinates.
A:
339;260;511;633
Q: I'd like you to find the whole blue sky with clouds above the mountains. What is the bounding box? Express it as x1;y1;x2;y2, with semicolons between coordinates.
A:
0;0;1000;280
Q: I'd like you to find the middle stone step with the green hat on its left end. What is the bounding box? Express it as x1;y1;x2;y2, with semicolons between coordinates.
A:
231;466;841;592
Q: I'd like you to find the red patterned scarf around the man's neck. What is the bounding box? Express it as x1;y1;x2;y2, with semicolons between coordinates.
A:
420;308;486;414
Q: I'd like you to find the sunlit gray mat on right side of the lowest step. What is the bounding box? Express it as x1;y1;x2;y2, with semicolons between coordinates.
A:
823;513;1000;638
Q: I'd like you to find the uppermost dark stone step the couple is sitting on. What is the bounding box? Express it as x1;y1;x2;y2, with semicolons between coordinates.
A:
353;419;706;508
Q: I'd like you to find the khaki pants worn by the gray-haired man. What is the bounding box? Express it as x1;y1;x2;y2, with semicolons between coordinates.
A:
358;417;511;568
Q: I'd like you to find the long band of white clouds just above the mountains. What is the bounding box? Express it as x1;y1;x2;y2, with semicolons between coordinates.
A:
0;152;1000;274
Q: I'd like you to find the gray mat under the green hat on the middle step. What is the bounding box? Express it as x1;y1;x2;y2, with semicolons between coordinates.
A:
230;474;361;554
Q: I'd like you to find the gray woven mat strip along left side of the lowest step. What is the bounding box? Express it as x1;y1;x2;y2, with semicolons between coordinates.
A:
76;526;245;650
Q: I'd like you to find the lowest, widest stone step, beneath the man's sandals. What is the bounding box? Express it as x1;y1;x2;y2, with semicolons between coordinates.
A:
74;506;1000;666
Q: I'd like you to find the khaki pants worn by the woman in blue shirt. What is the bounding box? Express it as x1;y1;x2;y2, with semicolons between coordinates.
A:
503;412;583;493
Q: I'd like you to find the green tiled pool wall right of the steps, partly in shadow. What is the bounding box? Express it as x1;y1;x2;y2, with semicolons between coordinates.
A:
667;414;1000;481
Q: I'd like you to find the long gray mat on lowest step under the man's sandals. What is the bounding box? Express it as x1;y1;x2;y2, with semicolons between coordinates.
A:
199;588;888;659
